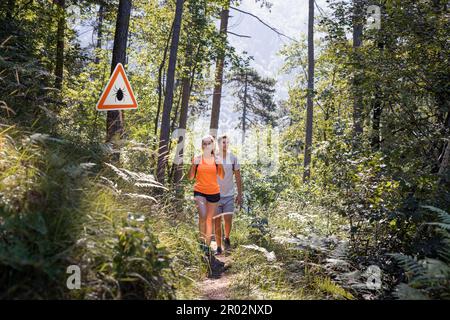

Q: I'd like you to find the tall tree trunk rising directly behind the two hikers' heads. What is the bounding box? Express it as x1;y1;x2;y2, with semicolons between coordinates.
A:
209;1;230;136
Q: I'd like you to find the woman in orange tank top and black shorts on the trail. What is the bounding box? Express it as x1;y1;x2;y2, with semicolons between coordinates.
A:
189;135;224;254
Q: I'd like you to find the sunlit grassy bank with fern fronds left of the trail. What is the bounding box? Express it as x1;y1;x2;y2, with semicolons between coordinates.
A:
0;128;173;299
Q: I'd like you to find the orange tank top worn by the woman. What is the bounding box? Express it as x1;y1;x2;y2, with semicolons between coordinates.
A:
194;156;220;194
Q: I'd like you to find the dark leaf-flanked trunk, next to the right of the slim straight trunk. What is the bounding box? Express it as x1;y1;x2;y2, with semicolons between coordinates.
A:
353;0;363;138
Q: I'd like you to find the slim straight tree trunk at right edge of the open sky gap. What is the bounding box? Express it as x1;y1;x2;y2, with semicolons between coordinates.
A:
303;0;314;182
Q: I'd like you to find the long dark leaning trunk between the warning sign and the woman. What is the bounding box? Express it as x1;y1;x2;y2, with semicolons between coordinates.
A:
157;0;183;183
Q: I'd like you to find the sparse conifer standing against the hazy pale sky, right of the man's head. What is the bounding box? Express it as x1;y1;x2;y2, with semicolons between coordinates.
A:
227;67;276;143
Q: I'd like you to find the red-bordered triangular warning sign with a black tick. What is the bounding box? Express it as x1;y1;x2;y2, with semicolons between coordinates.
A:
97;63;137;110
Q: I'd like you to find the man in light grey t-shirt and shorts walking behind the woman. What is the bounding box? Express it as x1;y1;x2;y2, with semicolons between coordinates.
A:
214;135;242;254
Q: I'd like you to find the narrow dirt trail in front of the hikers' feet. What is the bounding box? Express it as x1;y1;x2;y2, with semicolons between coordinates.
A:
200;242;236;300
